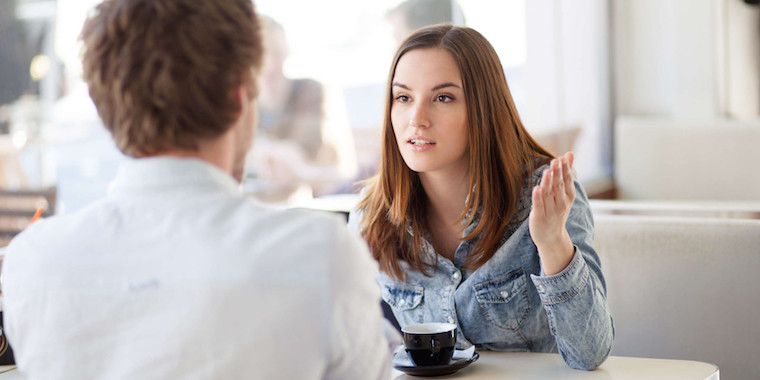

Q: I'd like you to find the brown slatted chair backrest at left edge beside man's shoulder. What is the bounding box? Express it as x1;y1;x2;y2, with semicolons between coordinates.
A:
0;186;58;247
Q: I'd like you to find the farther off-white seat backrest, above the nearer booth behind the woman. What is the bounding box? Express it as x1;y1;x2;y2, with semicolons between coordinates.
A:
615;117;760;201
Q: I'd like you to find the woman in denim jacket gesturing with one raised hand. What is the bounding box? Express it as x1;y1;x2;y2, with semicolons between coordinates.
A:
349;25;613;369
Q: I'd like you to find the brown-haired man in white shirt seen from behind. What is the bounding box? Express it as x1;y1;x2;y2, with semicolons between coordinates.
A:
3;0;398;379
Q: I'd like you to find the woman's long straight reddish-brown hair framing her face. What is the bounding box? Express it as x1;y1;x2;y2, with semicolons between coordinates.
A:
357;25;552;279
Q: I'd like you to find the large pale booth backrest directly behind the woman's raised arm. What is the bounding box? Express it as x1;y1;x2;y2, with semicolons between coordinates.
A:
594;214;760;379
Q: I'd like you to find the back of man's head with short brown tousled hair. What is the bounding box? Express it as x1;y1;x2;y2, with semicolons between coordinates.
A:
81;0;263;162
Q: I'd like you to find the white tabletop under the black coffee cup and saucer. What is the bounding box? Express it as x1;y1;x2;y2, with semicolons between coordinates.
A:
392;351;719;380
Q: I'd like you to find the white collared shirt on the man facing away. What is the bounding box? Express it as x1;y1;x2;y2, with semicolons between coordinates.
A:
2;157;392;380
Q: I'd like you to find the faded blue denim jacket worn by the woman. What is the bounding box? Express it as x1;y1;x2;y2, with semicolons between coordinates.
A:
349;166;614;369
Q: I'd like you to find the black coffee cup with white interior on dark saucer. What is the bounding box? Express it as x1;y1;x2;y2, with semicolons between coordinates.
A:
401;323;457;367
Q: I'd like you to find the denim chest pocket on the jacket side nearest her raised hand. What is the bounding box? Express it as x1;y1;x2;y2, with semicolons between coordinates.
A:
473;268;530;330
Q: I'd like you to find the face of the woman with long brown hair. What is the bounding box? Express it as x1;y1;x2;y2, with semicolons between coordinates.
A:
391;48;469;176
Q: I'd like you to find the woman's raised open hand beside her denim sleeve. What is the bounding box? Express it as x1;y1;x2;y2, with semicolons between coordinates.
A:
528;152;575;275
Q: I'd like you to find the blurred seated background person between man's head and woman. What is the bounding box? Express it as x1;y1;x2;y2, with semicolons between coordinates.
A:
246;16;357;201
